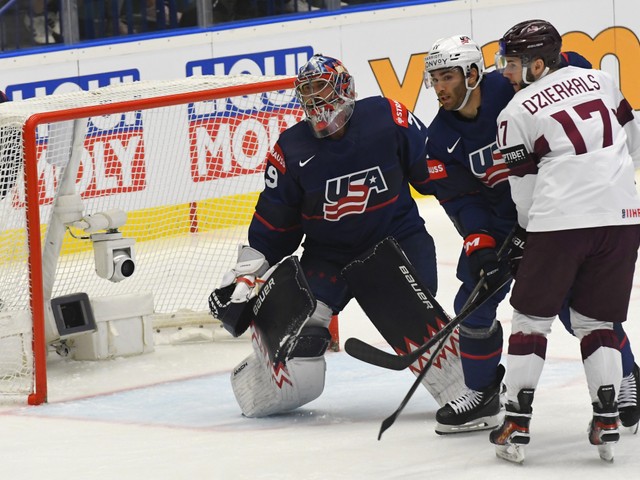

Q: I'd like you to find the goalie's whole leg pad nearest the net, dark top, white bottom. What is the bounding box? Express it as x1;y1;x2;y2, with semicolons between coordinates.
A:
231;257;332;417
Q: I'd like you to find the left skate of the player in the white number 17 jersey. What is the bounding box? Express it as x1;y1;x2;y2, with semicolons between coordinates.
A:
489;389;534;463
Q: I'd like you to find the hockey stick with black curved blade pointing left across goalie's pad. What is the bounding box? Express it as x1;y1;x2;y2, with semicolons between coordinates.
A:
344;228;515;370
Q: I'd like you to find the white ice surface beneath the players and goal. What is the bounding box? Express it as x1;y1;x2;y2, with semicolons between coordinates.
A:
0;200;640;480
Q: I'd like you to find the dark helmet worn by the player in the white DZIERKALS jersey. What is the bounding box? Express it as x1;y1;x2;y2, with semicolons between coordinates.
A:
496;20;562;85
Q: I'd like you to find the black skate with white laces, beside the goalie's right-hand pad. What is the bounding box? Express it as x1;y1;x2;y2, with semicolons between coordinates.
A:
436;365;504;435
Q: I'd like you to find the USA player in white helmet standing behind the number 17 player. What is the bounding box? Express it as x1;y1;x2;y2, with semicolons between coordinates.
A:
425;35;640;434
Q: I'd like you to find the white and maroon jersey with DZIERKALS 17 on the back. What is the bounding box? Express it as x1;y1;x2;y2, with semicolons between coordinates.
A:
497;67;640;232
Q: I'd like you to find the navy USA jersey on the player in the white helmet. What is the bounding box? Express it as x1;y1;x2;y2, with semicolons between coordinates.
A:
428;72;516;237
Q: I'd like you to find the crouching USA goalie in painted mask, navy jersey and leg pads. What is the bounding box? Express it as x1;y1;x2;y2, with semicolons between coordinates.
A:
209;54;464;417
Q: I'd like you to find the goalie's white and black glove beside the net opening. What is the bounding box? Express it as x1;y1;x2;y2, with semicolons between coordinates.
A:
209;245;269;337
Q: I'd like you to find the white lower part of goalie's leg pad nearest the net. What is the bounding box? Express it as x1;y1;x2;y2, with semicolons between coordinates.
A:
231;352;326;418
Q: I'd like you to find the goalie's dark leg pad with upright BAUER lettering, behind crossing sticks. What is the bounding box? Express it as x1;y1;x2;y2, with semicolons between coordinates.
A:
342;238;465;406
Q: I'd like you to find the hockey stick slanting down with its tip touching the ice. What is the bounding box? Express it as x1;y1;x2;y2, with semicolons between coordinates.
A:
378;227;516;440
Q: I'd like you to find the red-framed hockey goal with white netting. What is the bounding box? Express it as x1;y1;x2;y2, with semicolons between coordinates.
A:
0;75;302;404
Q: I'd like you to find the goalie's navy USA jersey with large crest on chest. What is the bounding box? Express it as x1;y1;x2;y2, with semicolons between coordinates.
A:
249;97;428;265
